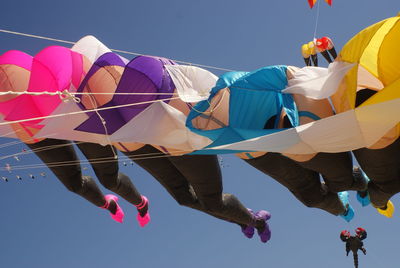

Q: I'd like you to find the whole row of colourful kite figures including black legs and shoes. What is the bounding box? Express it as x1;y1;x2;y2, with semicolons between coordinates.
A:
0;12;400;243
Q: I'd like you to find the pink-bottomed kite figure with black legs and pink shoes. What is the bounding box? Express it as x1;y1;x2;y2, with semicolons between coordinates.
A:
0;46;150;226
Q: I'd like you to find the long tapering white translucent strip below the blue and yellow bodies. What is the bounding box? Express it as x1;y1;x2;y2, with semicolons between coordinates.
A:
211;99;400;154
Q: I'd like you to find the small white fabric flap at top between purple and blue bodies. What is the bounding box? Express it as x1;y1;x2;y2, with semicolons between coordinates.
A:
165;65;218;102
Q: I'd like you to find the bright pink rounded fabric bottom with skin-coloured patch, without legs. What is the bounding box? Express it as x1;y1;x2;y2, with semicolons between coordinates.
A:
0;46;86;143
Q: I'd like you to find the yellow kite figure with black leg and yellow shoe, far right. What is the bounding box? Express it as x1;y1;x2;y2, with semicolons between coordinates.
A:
332;14;400;216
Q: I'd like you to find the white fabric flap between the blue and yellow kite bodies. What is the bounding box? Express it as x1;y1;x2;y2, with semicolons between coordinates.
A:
283;62;354;99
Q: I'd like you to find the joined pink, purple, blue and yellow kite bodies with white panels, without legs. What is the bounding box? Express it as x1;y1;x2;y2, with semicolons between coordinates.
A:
0;14;400;154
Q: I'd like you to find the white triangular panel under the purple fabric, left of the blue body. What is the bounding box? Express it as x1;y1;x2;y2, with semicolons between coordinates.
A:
111;102;211;151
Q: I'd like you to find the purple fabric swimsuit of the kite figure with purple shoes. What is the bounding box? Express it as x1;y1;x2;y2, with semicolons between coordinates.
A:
77;53;175;134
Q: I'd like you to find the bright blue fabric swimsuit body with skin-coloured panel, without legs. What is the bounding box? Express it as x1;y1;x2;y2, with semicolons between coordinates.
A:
186;66;298;153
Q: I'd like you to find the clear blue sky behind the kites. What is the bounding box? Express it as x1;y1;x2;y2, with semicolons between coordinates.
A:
0;0;400;268
